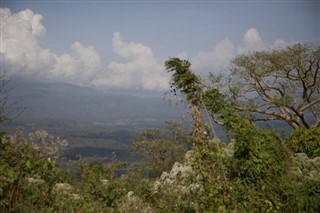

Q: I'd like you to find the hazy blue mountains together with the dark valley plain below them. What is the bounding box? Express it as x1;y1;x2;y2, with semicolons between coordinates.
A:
4;80;190;161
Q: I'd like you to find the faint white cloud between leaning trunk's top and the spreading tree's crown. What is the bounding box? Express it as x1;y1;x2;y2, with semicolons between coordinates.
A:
191;28;289;72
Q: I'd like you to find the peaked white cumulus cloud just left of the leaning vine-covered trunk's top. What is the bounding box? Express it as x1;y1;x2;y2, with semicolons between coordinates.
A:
93;32;169;90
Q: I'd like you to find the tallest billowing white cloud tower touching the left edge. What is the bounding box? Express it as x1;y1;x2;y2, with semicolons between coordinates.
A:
0;8;54;76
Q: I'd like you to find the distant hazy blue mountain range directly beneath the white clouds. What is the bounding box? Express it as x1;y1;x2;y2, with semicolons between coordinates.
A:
9;80;186;125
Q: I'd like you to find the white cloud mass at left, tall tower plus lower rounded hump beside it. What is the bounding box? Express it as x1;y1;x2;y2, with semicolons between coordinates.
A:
0;8;101;84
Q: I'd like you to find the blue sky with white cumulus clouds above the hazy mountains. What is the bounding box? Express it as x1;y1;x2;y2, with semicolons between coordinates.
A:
0;0;320;91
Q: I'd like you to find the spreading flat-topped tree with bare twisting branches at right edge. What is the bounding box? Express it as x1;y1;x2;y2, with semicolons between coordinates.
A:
228;44;320;129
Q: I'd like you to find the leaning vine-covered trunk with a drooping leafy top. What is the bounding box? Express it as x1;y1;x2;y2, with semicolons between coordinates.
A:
165;58;227;196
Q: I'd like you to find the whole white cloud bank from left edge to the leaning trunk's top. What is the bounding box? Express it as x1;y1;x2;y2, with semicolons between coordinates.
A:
0;8;169;90
